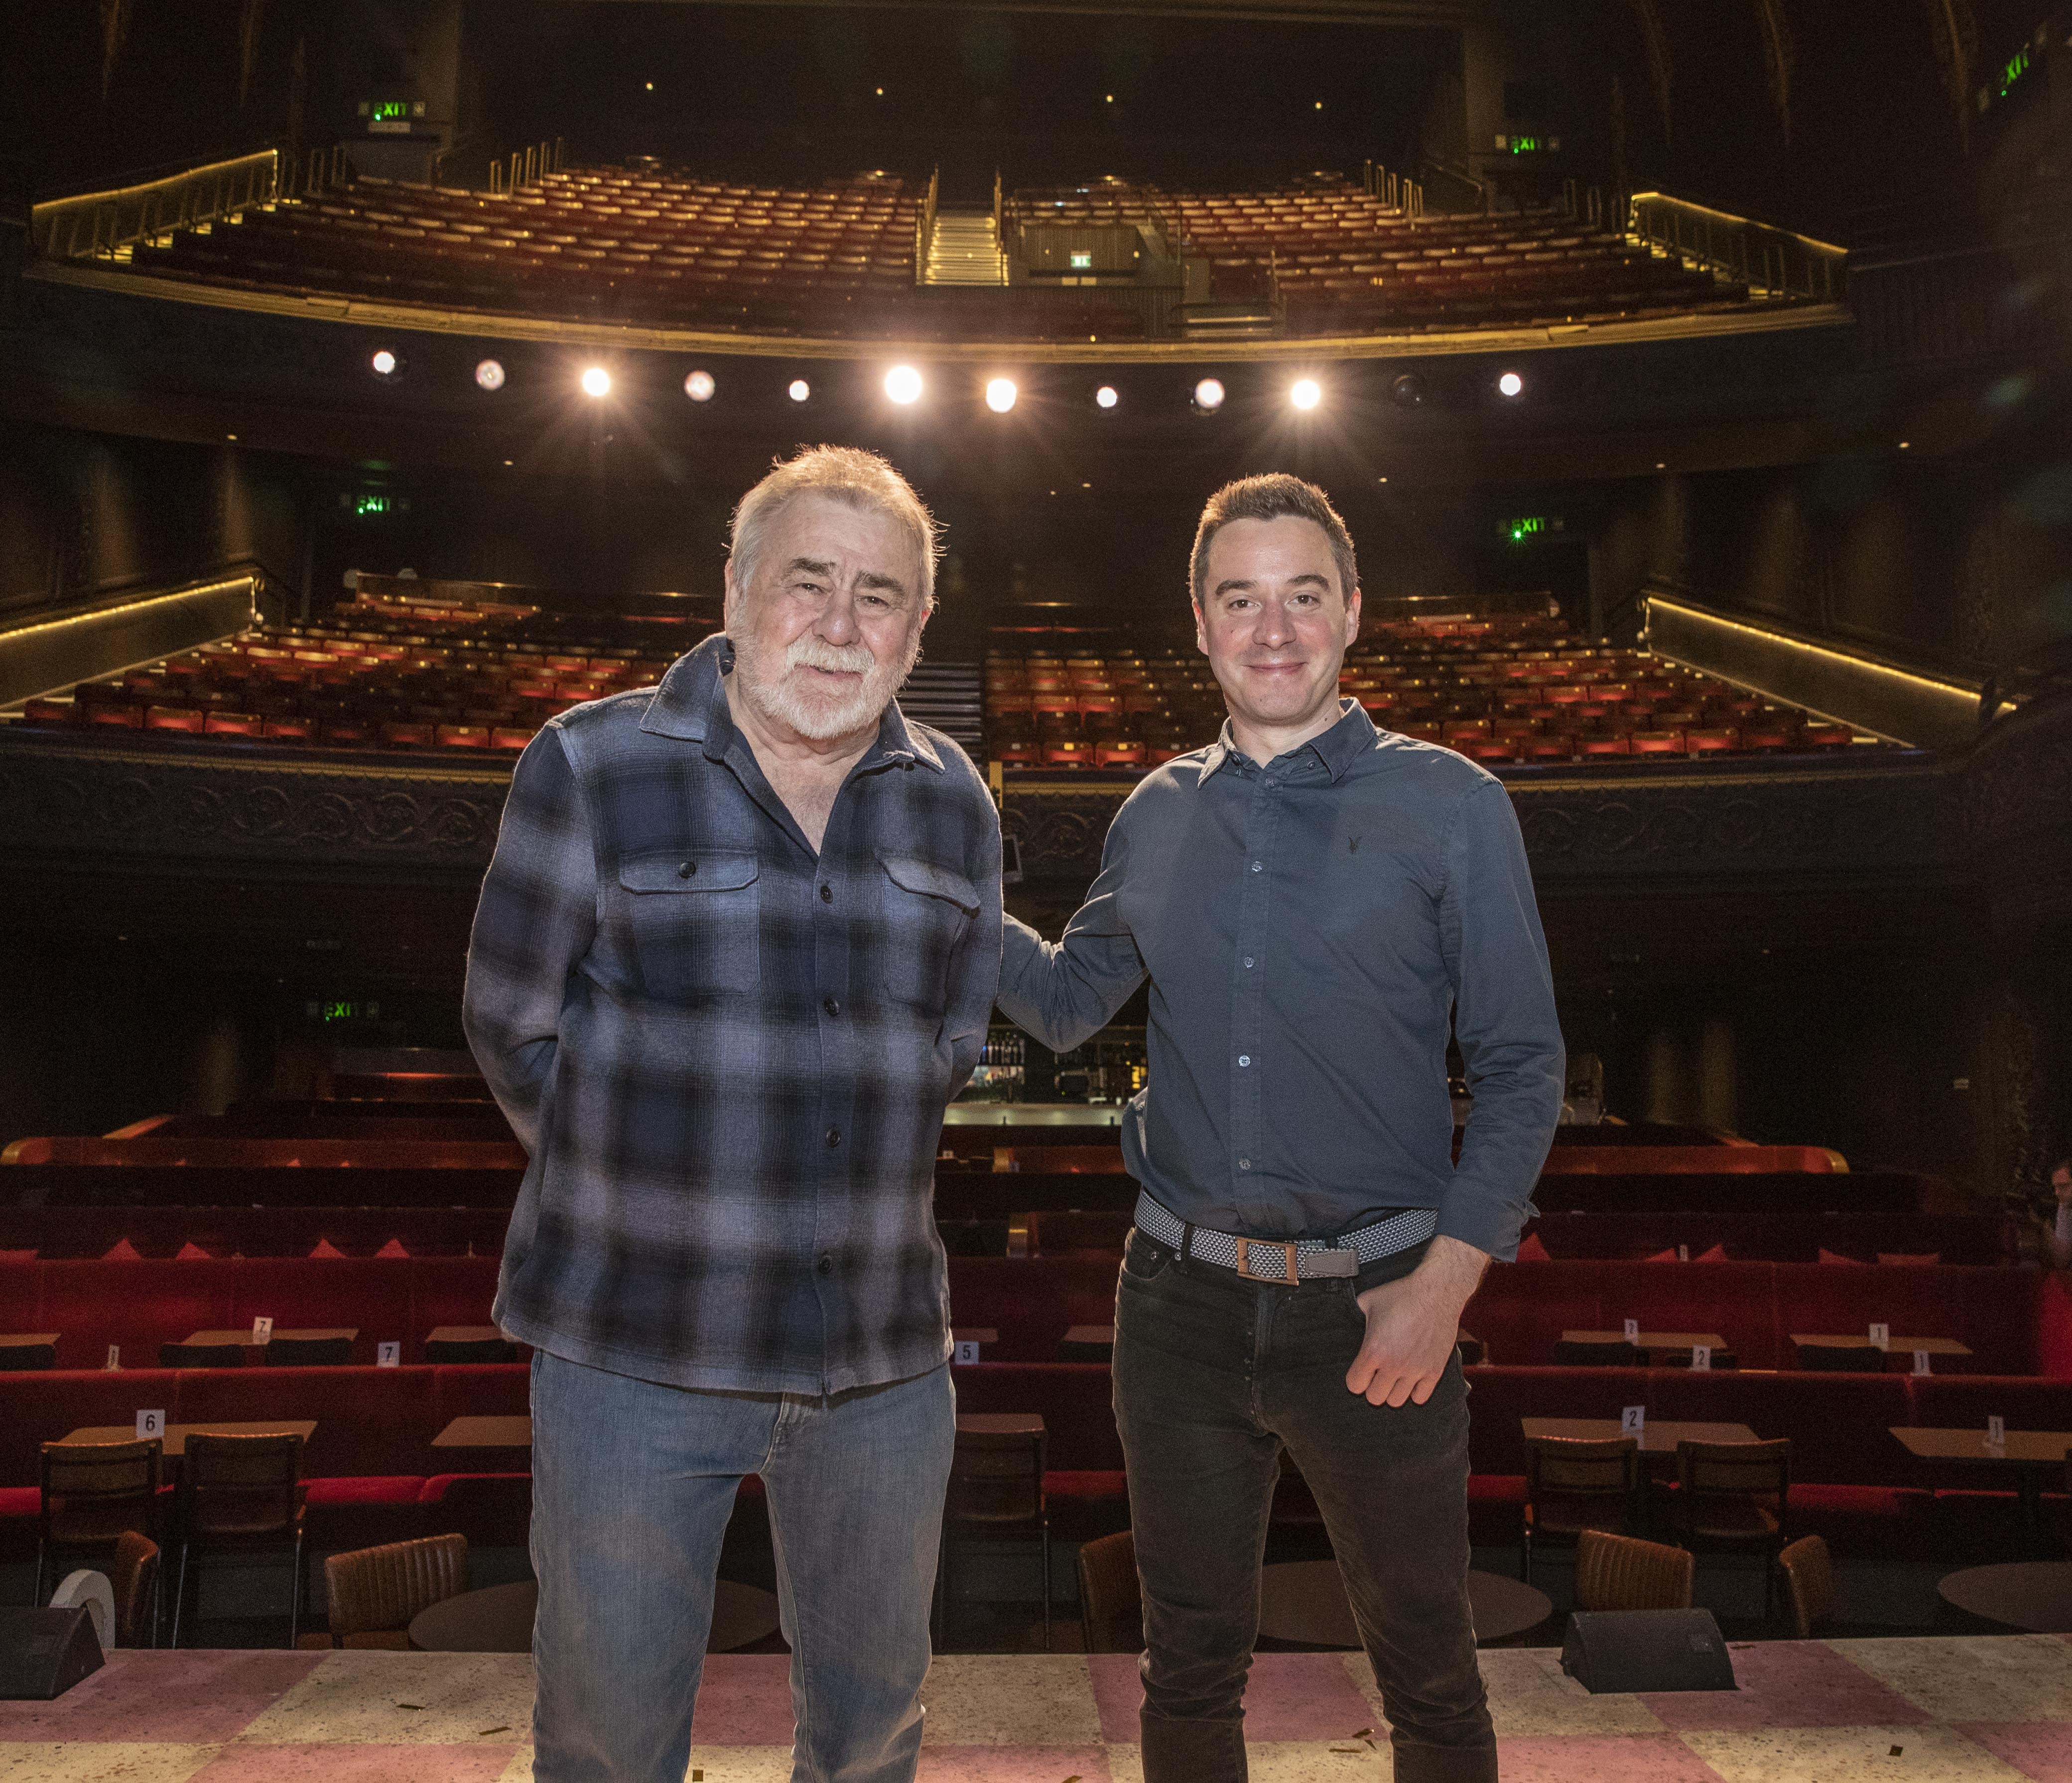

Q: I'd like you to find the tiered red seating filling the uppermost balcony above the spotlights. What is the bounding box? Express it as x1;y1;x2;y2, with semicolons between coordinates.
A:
113;168;1798;340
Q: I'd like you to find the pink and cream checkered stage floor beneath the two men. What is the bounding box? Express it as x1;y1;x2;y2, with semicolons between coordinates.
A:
0;1636;2072;1783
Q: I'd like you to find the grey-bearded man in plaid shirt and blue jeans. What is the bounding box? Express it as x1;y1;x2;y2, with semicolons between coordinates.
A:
466;448;1001;1783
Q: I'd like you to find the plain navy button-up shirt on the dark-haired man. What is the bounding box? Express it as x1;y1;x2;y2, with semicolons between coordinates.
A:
999;698;1562;1260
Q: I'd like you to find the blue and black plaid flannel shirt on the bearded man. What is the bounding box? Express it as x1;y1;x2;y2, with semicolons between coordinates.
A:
464;639;1019;1393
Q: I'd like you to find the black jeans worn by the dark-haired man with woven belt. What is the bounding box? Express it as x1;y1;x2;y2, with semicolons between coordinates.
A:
1115;1232;1496;1783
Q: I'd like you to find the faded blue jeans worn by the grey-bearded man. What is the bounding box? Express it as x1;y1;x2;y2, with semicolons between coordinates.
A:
532;1352;957;1783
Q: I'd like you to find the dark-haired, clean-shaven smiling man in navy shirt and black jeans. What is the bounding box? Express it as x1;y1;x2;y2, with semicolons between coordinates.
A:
1001;477;1562;1783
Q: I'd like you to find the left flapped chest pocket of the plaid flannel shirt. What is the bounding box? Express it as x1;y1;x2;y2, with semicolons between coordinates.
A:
620;848;763;1001
